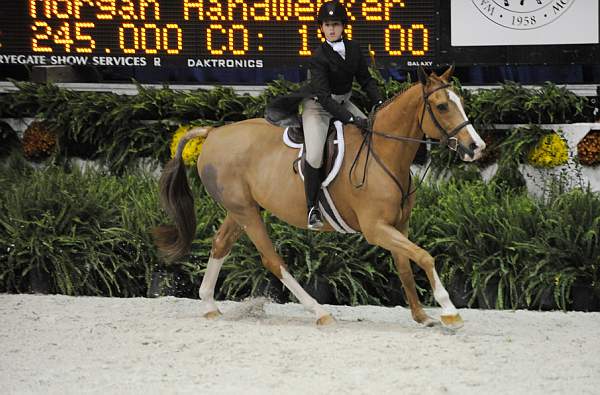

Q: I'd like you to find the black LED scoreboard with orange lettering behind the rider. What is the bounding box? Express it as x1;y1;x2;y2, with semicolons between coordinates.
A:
0;0;439;68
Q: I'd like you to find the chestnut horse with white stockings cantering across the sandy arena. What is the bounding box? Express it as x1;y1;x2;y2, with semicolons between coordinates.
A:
153;67;485;328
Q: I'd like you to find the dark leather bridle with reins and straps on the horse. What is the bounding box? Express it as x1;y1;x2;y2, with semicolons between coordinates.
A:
348;84;474;208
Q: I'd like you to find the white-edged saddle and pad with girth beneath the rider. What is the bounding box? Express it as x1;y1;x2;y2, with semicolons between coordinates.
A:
283;120;356;233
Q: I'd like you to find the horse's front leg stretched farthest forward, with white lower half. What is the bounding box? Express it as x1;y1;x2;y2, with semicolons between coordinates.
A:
363;221;463;328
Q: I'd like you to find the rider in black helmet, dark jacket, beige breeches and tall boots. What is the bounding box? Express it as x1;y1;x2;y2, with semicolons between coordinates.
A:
302;1;382;229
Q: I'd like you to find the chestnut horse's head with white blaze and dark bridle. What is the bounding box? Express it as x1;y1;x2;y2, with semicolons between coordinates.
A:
418;66;485;162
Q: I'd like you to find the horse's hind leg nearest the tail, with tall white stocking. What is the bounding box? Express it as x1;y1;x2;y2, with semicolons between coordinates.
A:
199;214;242;318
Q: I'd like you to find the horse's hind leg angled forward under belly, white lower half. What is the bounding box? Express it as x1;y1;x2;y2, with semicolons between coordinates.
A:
235;208;334;325
